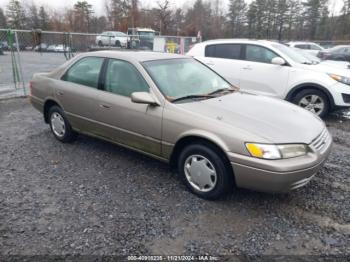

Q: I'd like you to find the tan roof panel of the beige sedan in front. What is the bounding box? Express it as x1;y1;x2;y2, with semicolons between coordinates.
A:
83;51;190;62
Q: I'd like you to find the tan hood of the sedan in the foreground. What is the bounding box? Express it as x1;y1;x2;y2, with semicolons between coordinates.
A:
178;92;325;144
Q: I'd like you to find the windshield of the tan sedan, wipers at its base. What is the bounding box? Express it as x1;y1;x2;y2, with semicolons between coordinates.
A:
143;58;231;100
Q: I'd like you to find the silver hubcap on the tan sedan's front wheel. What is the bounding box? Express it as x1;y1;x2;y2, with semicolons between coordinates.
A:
184;155;217;192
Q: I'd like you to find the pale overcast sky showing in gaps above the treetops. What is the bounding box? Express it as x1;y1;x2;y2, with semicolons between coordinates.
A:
0;0;343;15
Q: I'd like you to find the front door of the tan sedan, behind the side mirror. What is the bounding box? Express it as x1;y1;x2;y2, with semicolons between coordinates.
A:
93;59;163;156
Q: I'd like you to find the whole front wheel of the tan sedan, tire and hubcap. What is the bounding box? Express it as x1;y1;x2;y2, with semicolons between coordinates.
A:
178;143;234;200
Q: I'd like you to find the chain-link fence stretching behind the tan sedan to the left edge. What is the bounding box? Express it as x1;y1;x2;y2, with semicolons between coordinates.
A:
0;29;201;98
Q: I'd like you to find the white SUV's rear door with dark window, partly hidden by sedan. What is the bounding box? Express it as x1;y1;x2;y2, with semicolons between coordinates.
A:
198;44;243;87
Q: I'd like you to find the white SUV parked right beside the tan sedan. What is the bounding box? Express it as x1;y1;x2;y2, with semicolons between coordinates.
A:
187;39;350;117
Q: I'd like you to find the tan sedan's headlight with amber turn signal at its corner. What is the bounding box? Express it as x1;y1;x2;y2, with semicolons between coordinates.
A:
246;143;307;160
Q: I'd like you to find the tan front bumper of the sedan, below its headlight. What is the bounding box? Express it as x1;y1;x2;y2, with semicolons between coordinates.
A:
229;131;332;192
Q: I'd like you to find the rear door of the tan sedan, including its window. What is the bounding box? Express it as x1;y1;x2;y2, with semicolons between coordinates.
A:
55;57;105;131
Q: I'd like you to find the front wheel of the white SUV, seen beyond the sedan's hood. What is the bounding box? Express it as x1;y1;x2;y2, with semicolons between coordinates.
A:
292;89;330;117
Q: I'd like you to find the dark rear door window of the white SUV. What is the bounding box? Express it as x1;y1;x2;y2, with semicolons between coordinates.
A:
205;44;241;59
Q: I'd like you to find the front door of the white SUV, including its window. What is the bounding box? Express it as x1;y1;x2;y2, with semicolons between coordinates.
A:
240;44;291;98
